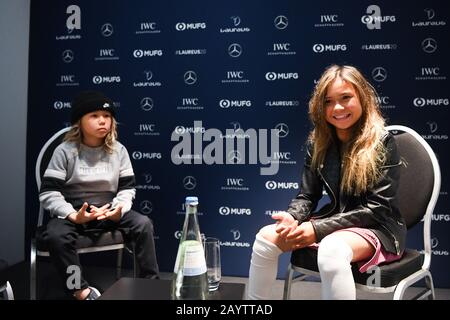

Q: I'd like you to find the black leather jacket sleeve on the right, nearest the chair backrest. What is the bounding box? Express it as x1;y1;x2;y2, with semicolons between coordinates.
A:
311;135;401;242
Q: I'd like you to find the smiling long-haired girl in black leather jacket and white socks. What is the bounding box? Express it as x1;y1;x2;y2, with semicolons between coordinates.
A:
248;65;406;299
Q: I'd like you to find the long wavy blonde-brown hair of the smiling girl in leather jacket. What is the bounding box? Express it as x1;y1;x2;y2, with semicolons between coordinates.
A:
309;65;386;195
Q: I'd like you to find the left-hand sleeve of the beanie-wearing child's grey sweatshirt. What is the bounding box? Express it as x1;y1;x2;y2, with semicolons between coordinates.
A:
39;147;77;219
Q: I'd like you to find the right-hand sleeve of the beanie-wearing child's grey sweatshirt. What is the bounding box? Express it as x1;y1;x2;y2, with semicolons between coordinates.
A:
111;146;136;216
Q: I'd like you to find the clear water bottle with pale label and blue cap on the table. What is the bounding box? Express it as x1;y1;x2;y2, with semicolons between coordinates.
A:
172;197;208;300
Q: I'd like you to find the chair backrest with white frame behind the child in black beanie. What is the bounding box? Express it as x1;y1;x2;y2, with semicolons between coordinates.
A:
35;127;70;226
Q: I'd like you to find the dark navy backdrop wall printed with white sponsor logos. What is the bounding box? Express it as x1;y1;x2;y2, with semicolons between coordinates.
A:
27;0;450;287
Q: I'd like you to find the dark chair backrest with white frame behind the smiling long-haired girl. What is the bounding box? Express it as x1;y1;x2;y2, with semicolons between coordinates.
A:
387;125;441;228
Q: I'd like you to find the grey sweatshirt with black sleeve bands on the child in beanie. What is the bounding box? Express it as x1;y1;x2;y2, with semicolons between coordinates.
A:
39;141;136;219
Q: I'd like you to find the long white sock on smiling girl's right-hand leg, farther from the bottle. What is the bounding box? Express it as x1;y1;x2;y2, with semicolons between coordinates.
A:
317;236;356;300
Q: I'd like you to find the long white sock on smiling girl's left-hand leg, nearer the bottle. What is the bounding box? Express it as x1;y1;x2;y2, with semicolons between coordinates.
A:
247;233;283;300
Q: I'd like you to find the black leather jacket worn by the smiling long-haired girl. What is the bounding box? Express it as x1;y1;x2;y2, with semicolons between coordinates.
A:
287;133;406;254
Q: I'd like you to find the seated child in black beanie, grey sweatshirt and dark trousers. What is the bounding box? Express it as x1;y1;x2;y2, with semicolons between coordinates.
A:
39;91;158;300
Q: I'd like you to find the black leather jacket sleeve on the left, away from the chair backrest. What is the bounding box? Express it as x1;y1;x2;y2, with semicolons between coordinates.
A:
287;144;323;222
